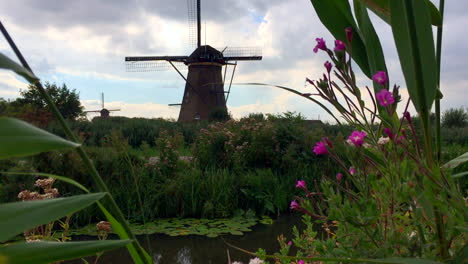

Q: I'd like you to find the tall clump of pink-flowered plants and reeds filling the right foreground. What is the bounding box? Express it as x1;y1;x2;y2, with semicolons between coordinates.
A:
234;0;468;263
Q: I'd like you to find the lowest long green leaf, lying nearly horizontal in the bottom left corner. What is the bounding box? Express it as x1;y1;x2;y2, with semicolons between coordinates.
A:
0;240;131;264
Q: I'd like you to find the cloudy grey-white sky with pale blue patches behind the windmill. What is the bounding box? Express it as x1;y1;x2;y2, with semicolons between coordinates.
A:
0;0;468;121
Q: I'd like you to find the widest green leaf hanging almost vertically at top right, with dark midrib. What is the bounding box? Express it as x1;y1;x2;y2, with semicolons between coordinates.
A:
390;0;438;117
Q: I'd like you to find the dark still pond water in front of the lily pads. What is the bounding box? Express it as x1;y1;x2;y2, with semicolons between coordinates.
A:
67;215;301;264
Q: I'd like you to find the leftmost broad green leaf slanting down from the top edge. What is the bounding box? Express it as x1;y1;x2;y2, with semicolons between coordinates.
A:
311;0;372;78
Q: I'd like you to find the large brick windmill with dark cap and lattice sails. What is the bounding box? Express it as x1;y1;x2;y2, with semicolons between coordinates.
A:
125;0;262;122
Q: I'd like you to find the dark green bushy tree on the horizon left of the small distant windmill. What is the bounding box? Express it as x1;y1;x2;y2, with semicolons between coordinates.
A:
12;82;83;119
